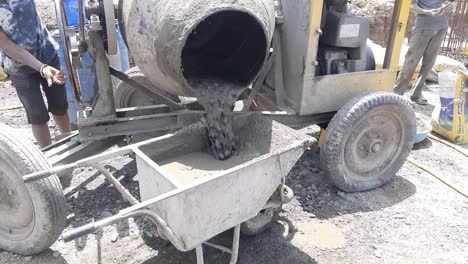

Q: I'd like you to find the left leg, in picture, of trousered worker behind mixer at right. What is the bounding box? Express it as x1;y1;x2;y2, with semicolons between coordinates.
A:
394;30;433;95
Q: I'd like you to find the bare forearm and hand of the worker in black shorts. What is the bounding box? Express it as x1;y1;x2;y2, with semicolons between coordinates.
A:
0;31;65;85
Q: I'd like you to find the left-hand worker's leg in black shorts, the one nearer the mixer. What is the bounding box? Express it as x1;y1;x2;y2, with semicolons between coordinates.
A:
41;57;71;134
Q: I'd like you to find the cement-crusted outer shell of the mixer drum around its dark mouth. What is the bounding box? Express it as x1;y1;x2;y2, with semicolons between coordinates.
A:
119;0;275;95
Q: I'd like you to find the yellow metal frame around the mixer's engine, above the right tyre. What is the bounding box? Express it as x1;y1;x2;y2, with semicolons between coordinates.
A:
297;0;411;115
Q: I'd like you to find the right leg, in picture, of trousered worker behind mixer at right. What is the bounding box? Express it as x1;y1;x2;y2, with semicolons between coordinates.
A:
411;29;447;100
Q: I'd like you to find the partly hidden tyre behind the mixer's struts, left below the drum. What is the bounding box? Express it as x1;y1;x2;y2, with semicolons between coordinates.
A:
114;67;180;108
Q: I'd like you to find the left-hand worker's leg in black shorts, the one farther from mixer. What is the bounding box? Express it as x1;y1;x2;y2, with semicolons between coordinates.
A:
11;73;51;147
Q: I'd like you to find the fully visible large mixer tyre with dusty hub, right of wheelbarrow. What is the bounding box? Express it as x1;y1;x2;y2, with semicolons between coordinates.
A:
320;92;416;192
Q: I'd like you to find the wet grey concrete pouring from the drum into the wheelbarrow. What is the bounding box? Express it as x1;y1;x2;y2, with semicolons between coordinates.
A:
188;79;246;160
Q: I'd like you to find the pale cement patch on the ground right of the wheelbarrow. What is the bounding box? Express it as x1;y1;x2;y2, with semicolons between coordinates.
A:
293;221;346;249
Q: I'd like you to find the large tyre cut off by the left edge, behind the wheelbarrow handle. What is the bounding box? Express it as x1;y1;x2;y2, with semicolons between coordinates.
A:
0;124;66;255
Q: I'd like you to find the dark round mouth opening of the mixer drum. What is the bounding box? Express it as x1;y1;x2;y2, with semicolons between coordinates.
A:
182;10;269;85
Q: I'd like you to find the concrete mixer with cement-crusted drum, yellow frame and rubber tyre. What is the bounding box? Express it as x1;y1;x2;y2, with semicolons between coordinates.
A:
51;0;415;191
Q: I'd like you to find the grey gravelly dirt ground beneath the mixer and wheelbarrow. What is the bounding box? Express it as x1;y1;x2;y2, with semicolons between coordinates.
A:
0;75;468;264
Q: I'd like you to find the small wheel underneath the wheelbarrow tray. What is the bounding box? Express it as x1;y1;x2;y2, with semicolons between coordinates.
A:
241;208;278;236
